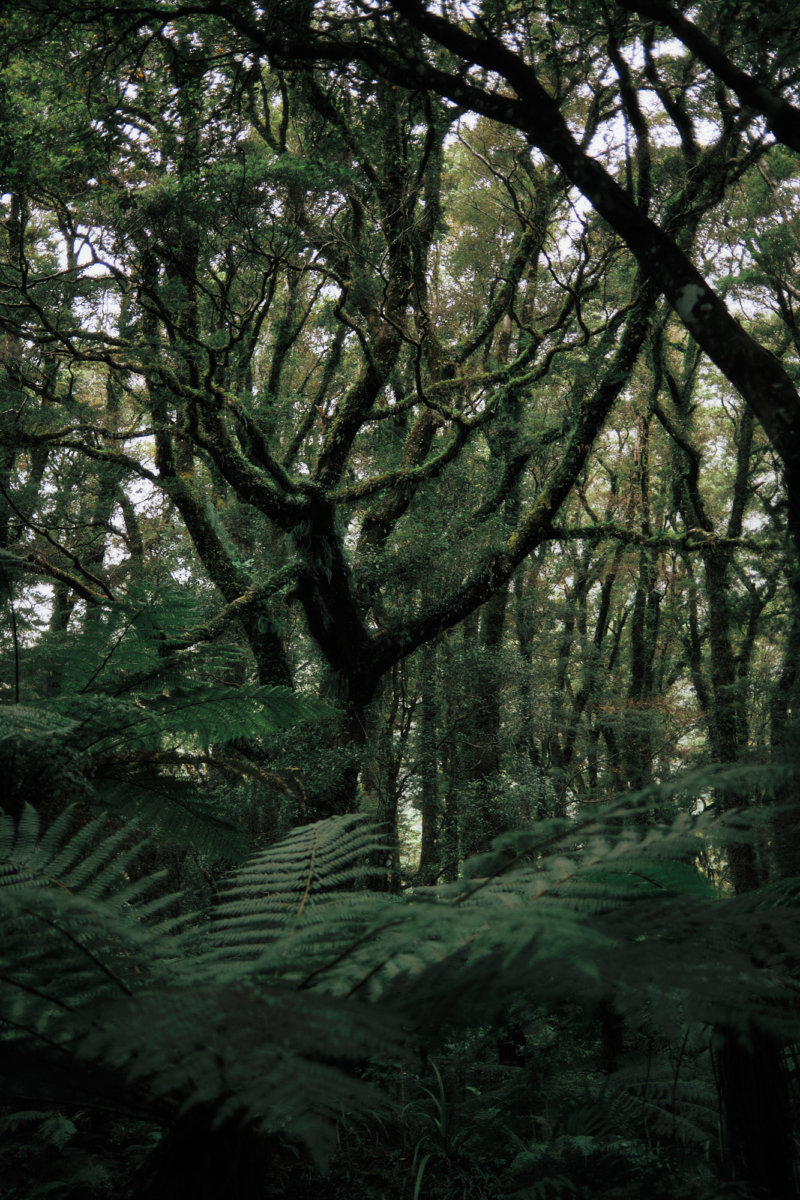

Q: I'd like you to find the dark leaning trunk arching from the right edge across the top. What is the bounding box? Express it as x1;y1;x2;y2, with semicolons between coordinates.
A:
154;0;800;549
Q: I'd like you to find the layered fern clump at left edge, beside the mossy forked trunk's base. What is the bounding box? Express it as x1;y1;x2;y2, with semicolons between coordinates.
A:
0;586;329;860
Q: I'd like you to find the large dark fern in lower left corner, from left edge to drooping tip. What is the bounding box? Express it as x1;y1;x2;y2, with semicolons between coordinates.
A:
0;810;398;1165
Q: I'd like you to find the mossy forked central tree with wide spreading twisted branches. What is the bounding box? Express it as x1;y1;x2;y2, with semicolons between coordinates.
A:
5;2;655;812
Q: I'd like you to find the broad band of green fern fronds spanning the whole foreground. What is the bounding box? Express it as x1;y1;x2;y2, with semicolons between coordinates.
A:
0;782;800;1195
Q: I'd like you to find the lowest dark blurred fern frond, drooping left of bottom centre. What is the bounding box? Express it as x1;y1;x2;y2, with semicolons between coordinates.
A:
78;983;401;1168
